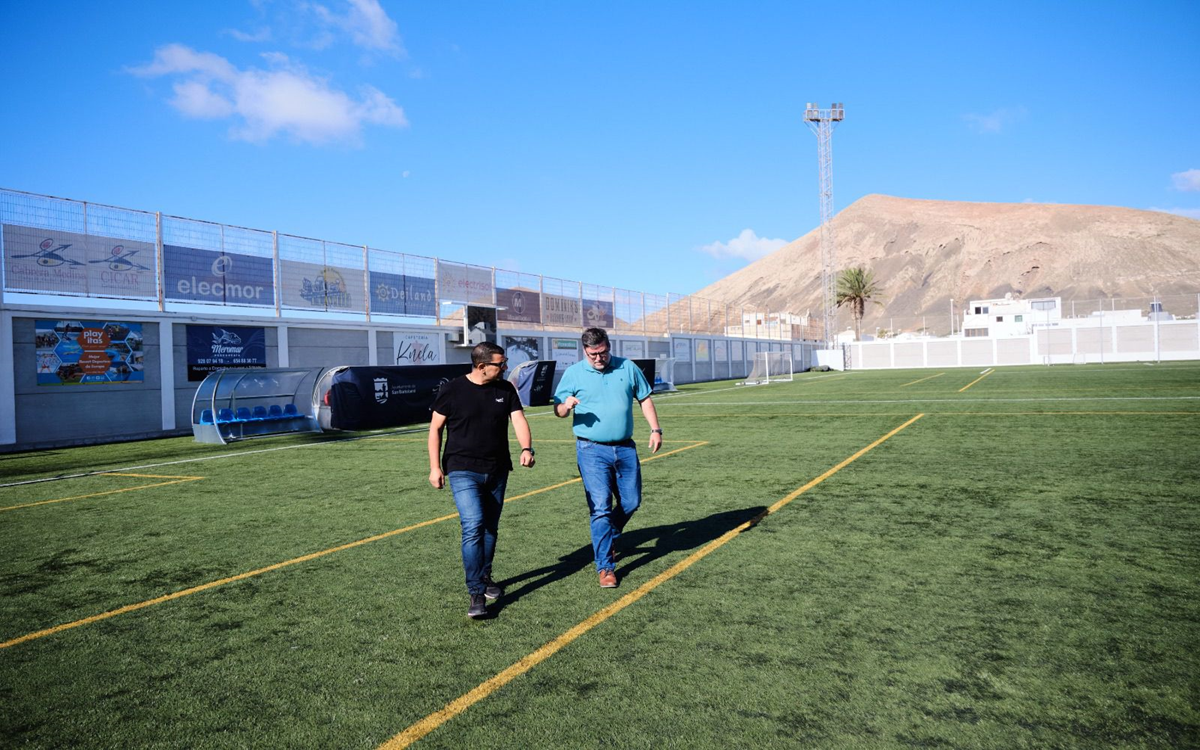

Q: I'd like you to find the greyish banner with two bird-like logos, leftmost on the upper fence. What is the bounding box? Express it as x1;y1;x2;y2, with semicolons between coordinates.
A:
4;224;158;299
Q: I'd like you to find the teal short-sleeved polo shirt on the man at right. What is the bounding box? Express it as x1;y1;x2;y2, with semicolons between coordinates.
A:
554;356;653;443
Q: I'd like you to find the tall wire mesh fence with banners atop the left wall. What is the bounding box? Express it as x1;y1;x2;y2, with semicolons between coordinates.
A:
0;190;822;340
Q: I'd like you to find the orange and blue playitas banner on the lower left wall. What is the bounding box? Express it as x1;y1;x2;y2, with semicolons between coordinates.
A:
34;320;145;385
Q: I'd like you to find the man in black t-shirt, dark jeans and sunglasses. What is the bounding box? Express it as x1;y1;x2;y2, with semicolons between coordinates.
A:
430;342;534;618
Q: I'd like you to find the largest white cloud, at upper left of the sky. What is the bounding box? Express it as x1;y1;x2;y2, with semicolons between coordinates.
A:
130;44;408;144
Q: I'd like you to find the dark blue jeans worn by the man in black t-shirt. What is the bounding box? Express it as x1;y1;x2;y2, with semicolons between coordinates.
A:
446;472;509;594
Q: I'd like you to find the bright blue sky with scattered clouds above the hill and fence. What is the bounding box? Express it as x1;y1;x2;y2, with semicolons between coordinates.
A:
0;0;1200;294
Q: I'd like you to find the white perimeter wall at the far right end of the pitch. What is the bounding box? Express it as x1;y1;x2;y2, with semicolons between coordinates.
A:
847;320;1200;370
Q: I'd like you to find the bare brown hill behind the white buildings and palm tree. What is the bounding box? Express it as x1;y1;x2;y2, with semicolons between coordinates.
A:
696;196;1200;331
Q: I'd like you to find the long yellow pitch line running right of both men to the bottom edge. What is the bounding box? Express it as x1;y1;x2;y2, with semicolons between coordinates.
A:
379;414;924;750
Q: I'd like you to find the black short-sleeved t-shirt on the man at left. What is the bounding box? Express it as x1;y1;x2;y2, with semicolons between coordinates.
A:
433;376;521;474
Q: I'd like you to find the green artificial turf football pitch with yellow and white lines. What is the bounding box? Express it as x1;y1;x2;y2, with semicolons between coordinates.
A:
0;362;1200;749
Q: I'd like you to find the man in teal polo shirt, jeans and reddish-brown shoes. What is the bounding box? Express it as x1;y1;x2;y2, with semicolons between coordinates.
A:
554;328;662;588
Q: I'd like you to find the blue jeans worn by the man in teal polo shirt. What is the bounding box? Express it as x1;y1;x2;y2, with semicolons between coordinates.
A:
575;440;642;571
